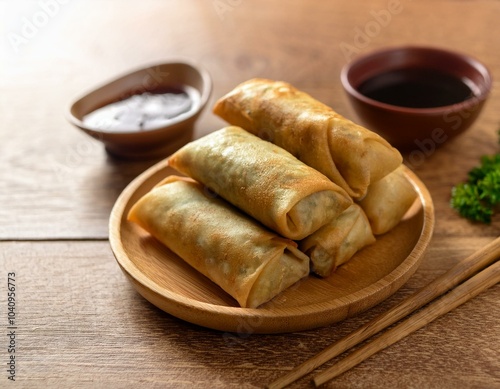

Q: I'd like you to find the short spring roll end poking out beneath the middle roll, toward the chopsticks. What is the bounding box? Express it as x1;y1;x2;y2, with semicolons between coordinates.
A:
299;204;375;277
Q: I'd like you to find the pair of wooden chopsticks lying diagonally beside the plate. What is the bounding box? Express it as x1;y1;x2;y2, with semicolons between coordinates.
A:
267;237;500;389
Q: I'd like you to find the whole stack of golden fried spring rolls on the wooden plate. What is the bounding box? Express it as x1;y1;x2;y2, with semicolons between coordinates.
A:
128;79;417;308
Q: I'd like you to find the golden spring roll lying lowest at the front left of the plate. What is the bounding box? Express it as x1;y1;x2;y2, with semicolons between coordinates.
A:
128;176;309;308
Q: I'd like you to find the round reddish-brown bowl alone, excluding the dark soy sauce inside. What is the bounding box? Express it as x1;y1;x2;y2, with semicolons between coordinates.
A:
341;46;492;151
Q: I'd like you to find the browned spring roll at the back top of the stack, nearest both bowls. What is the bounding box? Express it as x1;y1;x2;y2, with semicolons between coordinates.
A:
214;79;402;199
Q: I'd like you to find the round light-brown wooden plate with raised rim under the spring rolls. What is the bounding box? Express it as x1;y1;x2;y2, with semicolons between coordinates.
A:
110;160;434;333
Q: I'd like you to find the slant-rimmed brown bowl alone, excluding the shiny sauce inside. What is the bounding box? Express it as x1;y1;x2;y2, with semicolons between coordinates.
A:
67;60;212;159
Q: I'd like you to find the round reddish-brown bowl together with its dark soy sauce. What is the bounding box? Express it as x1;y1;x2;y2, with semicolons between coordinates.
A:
341;46;492;151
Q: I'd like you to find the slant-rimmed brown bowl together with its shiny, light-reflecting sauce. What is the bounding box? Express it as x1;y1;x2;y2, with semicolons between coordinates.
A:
67;60;212;159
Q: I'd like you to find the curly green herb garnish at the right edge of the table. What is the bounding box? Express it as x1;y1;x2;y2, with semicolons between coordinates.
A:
450;131;500;224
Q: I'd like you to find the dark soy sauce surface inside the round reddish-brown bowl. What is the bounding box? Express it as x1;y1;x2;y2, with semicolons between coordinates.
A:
358;68;473;108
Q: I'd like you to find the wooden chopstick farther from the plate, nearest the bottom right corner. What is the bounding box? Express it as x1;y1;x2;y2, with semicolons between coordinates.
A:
314;262;500;386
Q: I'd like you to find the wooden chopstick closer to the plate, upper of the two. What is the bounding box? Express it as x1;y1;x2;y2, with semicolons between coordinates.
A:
268;237;500;389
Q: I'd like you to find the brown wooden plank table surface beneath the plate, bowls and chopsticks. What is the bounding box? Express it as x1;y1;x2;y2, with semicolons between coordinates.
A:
0;0;500;389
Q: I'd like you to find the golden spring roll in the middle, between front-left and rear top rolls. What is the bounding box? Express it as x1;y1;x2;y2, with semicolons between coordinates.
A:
168;126;352;239
